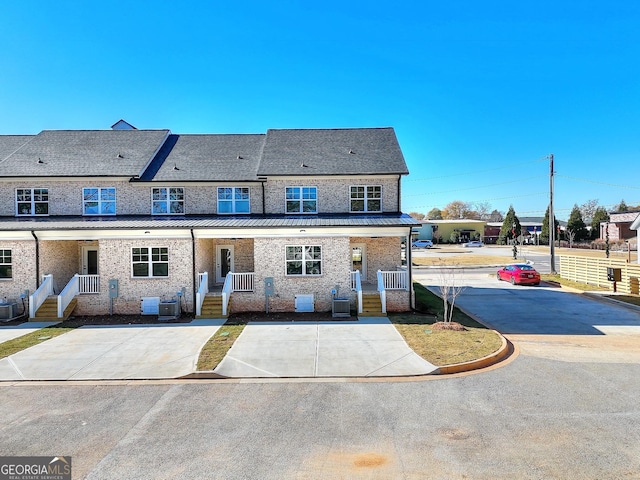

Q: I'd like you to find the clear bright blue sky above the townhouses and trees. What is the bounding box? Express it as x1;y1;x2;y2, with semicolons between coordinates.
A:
0;0;640;219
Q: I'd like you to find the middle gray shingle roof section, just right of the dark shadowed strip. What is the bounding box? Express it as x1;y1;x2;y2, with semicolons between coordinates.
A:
153;134;265;182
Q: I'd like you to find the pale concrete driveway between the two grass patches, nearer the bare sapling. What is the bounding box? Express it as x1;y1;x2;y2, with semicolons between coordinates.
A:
214;317;437;378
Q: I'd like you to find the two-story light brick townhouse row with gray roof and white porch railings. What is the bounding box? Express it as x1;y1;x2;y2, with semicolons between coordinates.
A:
0;121;416;318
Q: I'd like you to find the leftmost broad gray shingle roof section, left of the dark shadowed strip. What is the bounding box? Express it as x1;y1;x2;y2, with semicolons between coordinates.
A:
0;130;169;177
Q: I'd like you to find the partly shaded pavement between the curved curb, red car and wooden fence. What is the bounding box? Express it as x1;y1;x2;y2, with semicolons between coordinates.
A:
416;270;640;363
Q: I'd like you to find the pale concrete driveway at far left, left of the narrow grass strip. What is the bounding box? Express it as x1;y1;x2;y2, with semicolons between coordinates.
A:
0;320;224;380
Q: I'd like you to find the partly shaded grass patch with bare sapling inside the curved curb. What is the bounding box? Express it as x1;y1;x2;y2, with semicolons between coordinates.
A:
389;283;502;366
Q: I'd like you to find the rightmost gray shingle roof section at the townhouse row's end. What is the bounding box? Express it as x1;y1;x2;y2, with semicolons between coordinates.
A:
258;128;409;175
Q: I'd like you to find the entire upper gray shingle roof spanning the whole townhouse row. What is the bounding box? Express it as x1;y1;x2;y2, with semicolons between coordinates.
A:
0;128;409;182
